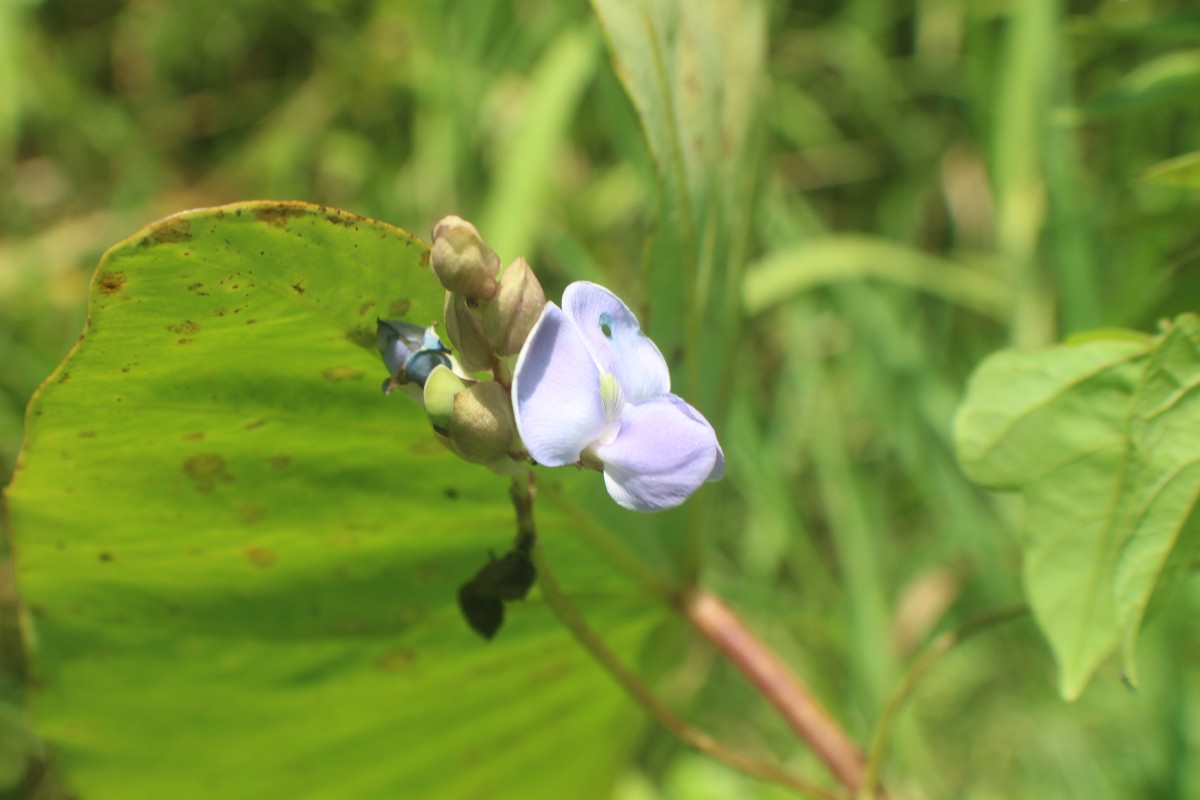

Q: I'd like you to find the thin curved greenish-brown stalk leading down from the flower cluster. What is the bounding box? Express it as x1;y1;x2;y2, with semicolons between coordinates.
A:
530;532;841;800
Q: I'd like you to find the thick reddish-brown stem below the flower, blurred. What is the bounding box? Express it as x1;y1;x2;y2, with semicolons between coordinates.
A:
683;589;864;790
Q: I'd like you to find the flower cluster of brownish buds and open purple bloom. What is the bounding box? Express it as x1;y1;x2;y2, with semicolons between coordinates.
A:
378;217;725;511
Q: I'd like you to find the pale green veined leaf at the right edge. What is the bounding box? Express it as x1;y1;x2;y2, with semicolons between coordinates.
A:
955;315;1200;699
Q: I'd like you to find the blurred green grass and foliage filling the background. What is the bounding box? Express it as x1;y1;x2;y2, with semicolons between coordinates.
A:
0;0;1200;800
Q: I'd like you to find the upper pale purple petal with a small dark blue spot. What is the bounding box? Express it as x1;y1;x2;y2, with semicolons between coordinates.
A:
563;281;671;403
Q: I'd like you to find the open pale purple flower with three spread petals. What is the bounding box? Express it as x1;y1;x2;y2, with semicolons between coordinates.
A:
512;282;725;511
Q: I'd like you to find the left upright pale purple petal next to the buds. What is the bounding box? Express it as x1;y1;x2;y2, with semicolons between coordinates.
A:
512;303;605;467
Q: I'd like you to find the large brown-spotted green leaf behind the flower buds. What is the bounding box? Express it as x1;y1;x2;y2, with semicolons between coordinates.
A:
10;203;659;800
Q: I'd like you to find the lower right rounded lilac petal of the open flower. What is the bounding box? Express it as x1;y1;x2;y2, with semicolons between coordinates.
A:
590;396;724;511
